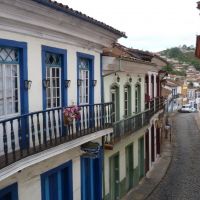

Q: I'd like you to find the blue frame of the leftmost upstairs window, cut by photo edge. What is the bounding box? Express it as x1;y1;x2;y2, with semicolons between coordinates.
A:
0;39;29;114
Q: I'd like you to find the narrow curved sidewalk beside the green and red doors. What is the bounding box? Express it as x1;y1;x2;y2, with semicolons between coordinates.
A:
122;122;172;200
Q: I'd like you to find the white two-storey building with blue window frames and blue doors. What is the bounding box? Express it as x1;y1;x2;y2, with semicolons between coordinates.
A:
0;0;125;200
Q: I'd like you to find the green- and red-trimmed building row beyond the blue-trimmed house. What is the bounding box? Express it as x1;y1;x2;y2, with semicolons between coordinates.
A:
103;44;166;200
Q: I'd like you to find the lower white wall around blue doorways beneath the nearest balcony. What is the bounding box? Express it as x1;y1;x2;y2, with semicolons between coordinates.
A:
0;147;83;200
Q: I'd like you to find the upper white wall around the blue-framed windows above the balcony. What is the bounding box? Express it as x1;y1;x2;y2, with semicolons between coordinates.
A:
0;31;101;111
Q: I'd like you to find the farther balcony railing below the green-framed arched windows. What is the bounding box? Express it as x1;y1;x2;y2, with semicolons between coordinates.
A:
110;97;164;143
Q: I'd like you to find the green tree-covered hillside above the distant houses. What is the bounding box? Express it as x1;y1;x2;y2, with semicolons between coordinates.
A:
160;45;200;75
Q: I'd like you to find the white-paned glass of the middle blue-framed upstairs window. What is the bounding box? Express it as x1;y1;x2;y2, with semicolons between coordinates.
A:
45;53;61;108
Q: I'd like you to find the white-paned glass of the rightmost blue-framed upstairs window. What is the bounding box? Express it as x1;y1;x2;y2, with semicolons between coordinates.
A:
79;59;90;104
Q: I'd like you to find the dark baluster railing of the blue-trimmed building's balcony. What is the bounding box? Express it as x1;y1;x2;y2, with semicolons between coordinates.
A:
0;103;112;169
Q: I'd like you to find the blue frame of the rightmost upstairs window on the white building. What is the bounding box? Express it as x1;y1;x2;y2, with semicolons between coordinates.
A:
76;52;94;105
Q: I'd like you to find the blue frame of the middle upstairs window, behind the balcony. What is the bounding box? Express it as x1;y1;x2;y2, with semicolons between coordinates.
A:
42;45;67;110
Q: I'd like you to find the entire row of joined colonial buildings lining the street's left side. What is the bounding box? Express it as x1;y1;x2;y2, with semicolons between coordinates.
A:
0;0;166;200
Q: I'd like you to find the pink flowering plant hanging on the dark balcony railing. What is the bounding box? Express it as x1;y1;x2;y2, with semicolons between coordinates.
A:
63;105;81;126
